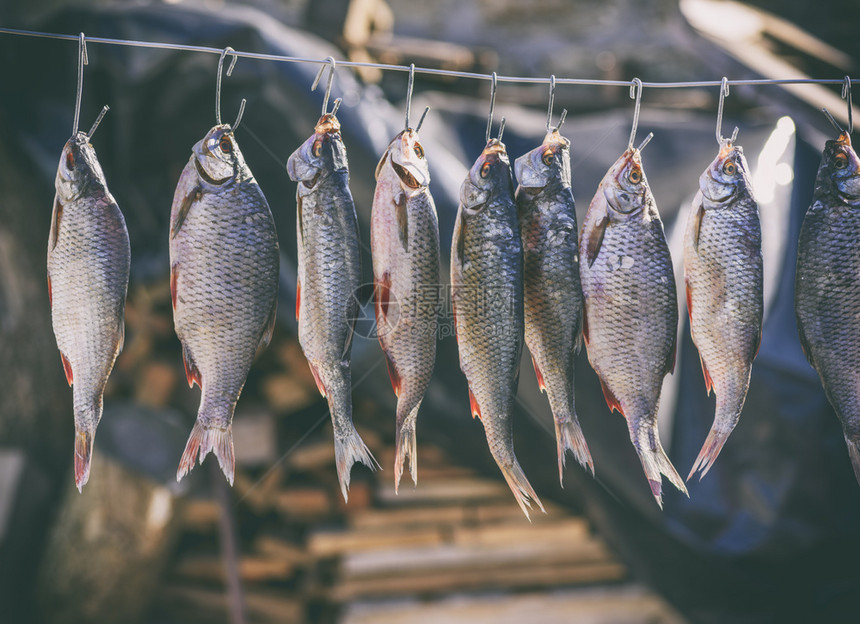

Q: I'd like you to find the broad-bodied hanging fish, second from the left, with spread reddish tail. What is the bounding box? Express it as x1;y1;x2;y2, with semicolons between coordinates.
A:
169;121;279;484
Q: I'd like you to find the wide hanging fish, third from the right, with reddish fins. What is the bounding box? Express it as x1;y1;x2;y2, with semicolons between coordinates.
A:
579;139;687;507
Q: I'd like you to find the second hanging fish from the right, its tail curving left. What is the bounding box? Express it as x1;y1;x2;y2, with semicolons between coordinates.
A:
684;139;764;479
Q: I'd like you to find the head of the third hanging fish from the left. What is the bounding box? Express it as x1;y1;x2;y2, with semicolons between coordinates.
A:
287;113;349;193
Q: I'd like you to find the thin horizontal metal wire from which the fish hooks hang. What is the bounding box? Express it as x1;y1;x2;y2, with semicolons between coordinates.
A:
0;27;858;89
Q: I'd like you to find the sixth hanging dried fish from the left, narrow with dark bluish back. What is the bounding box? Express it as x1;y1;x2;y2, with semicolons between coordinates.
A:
514;128;594;484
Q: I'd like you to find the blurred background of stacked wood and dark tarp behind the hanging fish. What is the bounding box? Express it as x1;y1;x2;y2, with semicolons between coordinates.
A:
0;0;860;624
